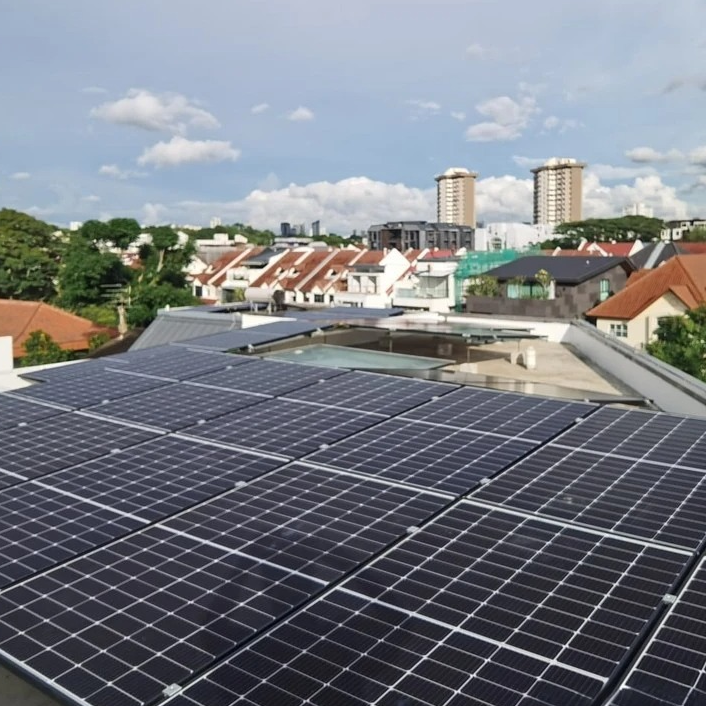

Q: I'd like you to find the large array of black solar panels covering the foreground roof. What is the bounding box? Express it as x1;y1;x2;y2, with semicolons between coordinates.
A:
0;338;706;706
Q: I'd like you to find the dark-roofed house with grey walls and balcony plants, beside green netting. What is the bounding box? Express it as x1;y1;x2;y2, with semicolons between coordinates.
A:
466;255;635;319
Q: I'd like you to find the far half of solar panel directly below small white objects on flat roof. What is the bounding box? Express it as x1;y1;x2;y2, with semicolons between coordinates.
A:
404;387;596;441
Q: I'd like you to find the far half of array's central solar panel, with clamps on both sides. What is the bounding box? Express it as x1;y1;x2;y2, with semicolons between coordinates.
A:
164;464;448;581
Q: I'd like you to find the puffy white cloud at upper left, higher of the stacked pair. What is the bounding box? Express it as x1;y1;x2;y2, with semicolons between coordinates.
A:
90;88;220;135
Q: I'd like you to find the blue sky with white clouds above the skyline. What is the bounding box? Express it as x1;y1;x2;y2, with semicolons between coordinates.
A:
0;0;706;234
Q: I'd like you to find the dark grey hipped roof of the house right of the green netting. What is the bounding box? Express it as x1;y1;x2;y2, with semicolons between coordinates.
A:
486;255;634;284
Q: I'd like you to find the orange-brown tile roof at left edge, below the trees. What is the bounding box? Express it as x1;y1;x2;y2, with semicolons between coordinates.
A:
0;299;115;358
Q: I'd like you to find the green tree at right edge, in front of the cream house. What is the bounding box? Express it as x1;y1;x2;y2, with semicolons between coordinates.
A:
647;305;706;382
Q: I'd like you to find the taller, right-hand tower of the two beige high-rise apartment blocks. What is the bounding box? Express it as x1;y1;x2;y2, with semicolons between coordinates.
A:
532;157;586;225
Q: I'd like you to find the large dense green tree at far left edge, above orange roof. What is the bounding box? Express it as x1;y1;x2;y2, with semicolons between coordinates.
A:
0;208;62;301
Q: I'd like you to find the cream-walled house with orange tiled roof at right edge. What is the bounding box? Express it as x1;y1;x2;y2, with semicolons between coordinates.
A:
586;254;706;348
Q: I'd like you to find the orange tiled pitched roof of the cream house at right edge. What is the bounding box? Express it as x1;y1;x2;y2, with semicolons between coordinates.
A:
586;255;706;320
